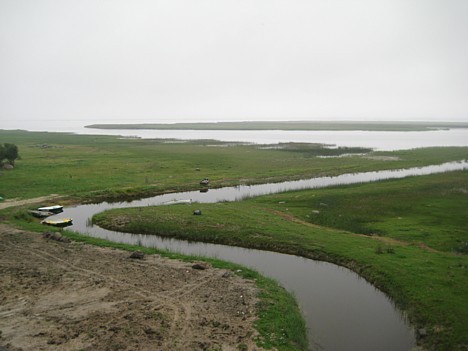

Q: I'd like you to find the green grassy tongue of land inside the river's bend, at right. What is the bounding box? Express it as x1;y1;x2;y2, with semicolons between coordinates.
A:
94;171;468;350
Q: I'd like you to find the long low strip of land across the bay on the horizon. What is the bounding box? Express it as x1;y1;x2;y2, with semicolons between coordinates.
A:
85;121;468;131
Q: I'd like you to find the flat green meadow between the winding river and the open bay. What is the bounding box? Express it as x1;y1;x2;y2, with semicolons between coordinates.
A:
0;130;468;202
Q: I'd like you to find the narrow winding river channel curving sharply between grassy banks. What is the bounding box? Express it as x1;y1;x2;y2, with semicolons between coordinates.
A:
57;161;468;351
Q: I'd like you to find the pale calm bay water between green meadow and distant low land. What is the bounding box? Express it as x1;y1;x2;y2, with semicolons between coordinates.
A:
0;120;468;151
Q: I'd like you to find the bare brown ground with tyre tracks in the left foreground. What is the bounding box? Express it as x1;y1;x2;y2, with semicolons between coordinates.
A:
0;223;260;351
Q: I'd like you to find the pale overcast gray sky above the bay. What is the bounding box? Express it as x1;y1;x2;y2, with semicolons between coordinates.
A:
0;0;468;128
